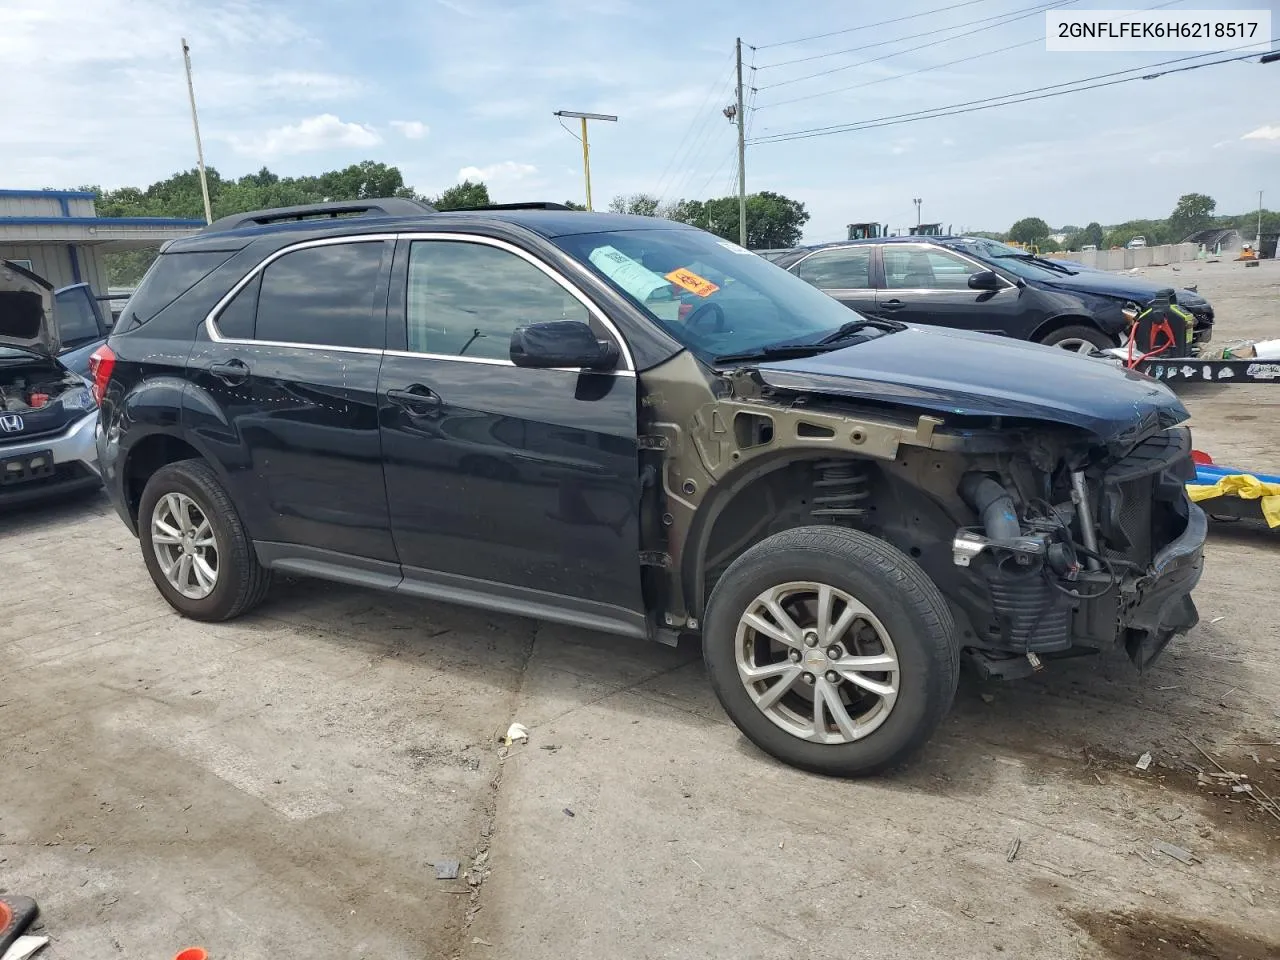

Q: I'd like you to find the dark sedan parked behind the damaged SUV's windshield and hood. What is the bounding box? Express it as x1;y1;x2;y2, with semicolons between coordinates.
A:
774;237;1213;353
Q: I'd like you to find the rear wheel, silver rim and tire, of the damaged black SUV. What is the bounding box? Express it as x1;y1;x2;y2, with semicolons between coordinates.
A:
138;460;271;621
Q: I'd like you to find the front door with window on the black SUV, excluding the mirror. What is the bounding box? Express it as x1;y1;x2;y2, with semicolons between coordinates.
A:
379;234;643;628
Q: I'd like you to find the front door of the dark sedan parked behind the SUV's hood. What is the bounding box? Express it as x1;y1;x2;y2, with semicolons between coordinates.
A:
876;243;1021;335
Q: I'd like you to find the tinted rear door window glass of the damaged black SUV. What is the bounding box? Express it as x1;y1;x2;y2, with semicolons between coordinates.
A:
253;241;387;348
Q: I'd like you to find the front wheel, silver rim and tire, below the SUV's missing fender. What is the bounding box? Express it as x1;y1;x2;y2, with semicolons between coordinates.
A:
703;526;960;777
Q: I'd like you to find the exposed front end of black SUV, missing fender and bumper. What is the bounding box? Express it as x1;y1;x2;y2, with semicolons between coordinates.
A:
641;350;1207;678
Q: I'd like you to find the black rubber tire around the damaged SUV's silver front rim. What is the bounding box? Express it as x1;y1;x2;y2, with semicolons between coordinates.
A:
703;526;960;777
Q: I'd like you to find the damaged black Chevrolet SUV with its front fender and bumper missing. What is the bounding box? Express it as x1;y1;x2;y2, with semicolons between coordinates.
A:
93;200;1206;776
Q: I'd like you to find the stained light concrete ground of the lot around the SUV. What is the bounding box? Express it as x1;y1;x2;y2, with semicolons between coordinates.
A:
0;261;1280;960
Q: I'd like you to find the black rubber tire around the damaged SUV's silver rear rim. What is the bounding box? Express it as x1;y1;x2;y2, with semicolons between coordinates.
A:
138;460;271;621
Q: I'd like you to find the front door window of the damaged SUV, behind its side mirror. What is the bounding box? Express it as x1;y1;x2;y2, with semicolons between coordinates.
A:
407;241;590;360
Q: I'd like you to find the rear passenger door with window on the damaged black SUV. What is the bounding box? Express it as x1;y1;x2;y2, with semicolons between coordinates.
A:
183;238;396;563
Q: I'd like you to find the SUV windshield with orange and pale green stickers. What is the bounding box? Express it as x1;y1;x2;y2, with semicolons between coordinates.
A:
556;229;859;362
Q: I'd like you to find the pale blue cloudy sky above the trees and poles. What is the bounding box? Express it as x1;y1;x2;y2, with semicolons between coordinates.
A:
0;0;1280;241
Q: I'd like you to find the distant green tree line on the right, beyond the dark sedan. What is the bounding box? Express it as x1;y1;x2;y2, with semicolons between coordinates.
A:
1003;193;1280;252
